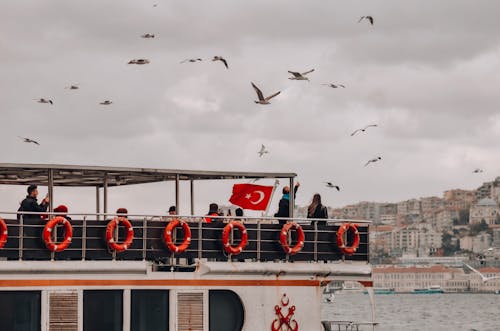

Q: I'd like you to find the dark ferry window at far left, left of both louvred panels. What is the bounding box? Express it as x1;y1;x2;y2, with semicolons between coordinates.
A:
0;291;41;331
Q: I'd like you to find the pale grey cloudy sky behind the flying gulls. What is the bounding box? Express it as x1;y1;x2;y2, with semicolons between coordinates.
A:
0;0;500;217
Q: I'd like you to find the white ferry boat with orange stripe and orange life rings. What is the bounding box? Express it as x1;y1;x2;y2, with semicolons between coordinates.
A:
0;164;376;331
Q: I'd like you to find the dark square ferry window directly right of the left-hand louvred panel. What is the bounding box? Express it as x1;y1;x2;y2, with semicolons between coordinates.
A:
83;290;123;331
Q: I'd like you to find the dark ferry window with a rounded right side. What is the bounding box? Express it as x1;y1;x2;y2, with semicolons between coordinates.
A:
209;290;245;331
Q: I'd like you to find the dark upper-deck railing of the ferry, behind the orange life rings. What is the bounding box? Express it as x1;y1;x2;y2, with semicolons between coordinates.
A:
0;212;369;264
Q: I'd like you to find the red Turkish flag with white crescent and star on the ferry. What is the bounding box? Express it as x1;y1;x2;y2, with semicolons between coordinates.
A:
229;184;273;210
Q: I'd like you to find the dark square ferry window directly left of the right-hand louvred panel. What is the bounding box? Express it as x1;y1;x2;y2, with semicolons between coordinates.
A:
130;290;169;331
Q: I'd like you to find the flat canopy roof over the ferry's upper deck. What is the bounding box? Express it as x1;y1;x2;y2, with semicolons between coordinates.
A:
0;163;297;187
